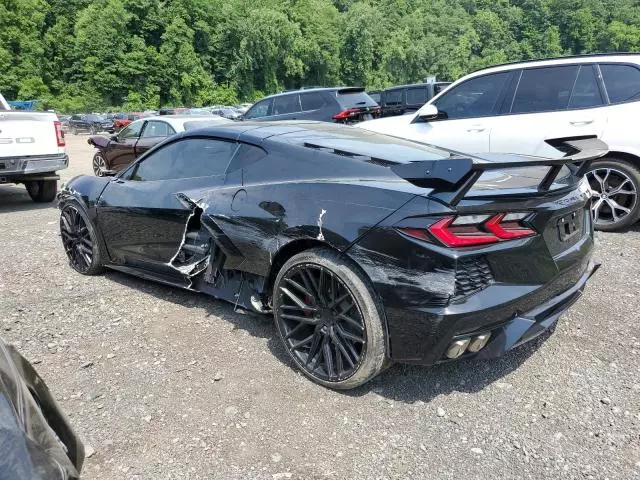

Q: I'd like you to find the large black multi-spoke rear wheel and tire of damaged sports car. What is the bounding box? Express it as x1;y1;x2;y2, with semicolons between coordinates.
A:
273;247;387;390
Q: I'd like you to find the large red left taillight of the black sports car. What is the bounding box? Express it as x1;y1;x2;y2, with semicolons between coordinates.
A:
401;213;536;247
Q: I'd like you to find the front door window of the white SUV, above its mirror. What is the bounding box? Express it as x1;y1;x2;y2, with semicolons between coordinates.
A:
434;72;511;120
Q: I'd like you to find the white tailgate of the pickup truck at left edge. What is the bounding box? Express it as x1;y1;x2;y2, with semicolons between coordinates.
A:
0;111;64;157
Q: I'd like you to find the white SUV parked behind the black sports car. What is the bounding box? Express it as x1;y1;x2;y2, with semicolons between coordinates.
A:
358;54;640;230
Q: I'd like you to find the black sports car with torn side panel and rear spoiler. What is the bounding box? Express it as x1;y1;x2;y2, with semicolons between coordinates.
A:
59;122;606;389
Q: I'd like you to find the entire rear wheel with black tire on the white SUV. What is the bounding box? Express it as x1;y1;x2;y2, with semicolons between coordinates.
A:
586;157;640;232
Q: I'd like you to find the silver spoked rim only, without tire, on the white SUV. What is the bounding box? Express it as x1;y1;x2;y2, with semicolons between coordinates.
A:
587;162;638;230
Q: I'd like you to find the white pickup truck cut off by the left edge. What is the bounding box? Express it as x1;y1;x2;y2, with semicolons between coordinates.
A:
0;94;69;202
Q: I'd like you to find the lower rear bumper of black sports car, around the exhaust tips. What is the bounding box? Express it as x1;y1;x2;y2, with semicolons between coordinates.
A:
386;256;600;365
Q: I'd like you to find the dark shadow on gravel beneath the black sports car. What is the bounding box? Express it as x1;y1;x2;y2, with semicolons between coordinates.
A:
106;271;551;403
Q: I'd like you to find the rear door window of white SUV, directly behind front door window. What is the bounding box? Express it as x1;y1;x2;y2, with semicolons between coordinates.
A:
511;65;578;113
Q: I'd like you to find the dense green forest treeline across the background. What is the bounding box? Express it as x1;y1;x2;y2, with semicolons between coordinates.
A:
0;0;640;112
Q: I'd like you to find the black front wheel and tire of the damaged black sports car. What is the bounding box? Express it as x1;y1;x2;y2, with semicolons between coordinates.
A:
60;201;105;275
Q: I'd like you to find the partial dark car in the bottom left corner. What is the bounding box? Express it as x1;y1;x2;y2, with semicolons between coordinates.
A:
0;339;84;480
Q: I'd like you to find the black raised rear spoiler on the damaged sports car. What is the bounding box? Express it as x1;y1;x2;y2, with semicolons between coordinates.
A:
390;138;609;206
